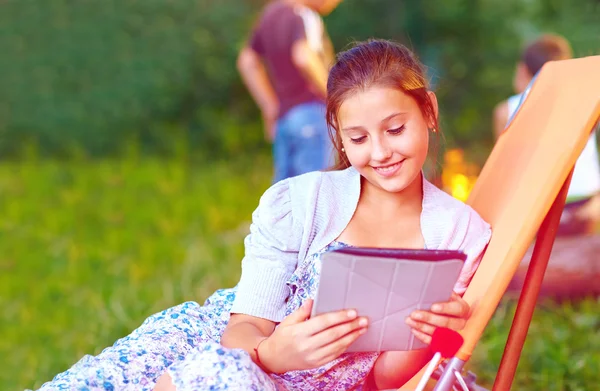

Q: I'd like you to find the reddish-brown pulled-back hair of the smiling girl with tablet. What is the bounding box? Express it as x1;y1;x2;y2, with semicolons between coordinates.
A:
326;39;438;170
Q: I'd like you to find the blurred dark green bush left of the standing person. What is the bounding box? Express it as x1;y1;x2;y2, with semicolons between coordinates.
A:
0;0;262;156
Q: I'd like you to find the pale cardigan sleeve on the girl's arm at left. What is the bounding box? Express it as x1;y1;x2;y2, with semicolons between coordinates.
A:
231;180;301;322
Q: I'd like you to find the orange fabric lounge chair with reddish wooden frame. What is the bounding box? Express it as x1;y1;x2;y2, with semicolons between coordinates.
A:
400;56;600;391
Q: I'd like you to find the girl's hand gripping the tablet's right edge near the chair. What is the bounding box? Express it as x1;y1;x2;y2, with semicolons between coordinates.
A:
406;292;471;345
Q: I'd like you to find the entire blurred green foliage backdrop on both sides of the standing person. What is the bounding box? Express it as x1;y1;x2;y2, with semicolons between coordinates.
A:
0;0;600;161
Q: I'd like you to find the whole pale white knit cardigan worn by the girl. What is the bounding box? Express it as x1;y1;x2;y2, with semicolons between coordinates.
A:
231;167;491;322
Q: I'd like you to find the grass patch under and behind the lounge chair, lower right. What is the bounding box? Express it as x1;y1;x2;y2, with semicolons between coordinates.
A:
469;298;600;391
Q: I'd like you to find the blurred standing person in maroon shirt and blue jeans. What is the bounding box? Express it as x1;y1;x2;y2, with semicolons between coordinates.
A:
237;0;341;182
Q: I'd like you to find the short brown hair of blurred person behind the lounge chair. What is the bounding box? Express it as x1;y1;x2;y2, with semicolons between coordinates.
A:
521;34;573;76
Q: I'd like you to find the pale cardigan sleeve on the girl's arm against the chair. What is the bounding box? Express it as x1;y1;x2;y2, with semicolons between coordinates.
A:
454;205;492;295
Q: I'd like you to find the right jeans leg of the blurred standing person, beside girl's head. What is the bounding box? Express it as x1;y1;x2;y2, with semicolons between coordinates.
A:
290;103;333;175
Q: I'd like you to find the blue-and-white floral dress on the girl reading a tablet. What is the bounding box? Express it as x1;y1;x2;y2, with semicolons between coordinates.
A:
40;241;378;391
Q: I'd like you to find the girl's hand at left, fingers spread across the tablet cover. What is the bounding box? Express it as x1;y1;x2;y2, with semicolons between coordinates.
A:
258;300;368;373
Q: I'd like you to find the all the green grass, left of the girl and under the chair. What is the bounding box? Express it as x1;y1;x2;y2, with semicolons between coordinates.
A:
0;157;600;390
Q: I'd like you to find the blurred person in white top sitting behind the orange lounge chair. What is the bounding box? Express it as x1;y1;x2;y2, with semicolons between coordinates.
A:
494;34;600;235
